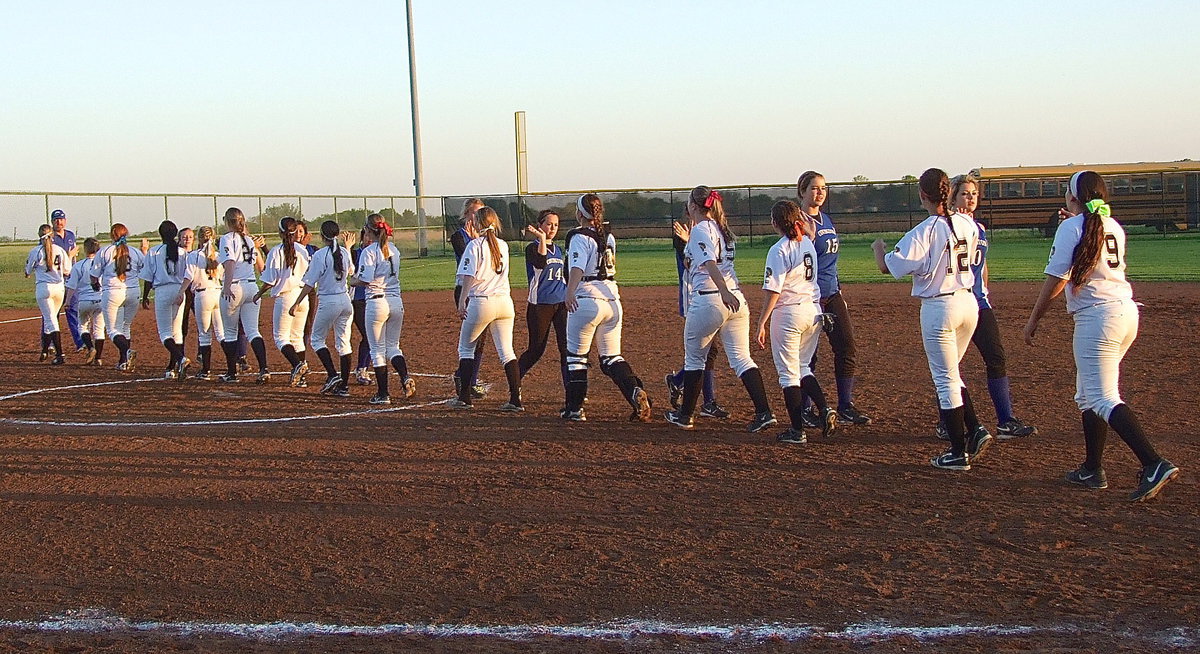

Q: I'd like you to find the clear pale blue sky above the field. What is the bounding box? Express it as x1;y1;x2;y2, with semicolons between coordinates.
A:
0;0;1200;213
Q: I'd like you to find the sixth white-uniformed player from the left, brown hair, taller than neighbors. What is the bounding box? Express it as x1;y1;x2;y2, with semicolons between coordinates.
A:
217;206;271;384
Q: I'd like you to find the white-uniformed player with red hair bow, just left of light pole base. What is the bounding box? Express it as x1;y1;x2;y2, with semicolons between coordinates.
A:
352;214;416;404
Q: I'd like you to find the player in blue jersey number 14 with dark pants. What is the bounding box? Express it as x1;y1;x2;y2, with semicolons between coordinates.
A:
517;209;566;391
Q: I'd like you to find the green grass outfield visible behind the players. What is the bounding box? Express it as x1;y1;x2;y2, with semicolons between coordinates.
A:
0;229;1200;308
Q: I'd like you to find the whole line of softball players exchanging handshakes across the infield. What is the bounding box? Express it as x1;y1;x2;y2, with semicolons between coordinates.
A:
26;168;1178;500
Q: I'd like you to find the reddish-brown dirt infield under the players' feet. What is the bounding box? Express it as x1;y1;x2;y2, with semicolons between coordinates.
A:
0;283;1200;652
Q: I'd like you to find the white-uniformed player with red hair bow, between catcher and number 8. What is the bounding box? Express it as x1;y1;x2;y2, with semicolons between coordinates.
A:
666;186;776;433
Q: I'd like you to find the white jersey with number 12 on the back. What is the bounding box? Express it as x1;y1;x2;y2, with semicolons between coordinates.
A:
884;214;979;298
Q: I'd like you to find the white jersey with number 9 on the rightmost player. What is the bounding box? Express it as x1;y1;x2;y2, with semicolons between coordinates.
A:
1045;208;1133;313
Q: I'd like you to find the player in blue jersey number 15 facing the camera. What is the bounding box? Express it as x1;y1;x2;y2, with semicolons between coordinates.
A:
796;170;871;427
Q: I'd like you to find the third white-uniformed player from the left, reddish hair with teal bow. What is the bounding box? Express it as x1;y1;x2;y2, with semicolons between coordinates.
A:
91;222;145;372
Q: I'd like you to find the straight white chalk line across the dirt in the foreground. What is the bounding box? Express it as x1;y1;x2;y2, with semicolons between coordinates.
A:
0;610;1200;647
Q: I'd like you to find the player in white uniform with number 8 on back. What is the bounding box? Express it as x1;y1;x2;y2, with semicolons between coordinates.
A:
756;200;838;444
